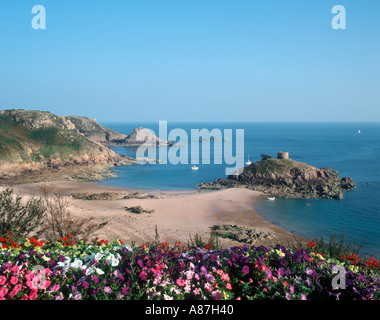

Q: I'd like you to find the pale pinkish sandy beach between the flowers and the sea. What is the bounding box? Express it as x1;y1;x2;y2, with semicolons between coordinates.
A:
6;181;307;247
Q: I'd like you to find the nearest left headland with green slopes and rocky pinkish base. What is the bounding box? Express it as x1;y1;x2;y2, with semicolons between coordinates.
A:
0;110;137;180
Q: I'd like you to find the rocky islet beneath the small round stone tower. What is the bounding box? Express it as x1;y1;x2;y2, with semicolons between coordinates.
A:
199;159;356;199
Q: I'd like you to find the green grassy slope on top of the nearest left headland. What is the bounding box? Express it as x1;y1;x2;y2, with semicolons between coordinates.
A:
0;110;93;163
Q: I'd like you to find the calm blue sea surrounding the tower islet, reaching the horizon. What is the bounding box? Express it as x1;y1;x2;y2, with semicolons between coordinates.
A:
99;122;380;259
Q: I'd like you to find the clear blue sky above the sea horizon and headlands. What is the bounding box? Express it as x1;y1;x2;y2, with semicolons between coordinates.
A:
0;0;380;122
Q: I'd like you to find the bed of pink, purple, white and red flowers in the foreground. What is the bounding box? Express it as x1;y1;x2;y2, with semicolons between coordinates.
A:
0;234;379;300
